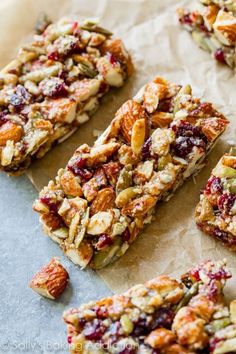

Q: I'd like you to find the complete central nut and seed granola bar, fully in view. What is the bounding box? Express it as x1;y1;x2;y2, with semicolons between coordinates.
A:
34;77;228;269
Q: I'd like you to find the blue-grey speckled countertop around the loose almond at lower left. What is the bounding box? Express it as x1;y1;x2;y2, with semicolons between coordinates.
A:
0;174;111;354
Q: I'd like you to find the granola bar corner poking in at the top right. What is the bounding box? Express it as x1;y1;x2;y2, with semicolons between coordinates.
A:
178;1;236;69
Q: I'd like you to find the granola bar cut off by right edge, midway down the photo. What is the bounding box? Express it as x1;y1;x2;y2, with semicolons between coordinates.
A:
195;148;236;251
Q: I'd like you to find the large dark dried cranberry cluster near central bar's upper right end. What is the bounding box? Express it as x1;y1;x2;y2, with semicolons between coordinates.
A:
172;122;207;158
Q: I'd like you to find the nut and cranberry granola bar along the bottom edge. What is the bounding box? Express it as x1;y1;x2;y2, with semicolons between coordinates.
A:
63;261;236;354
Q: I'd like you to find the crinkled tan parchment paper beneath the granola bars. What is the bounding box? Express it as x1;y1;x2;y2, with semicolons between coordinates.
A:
0;0;236;297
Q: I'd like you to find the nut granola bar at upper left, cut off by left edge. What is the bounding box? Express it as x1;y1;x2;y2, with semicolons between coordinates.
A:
0;17;132;174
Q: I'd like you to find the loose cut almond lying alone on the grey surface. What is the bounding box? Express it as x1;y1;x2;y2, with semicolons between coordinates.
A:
29;257;69;300
